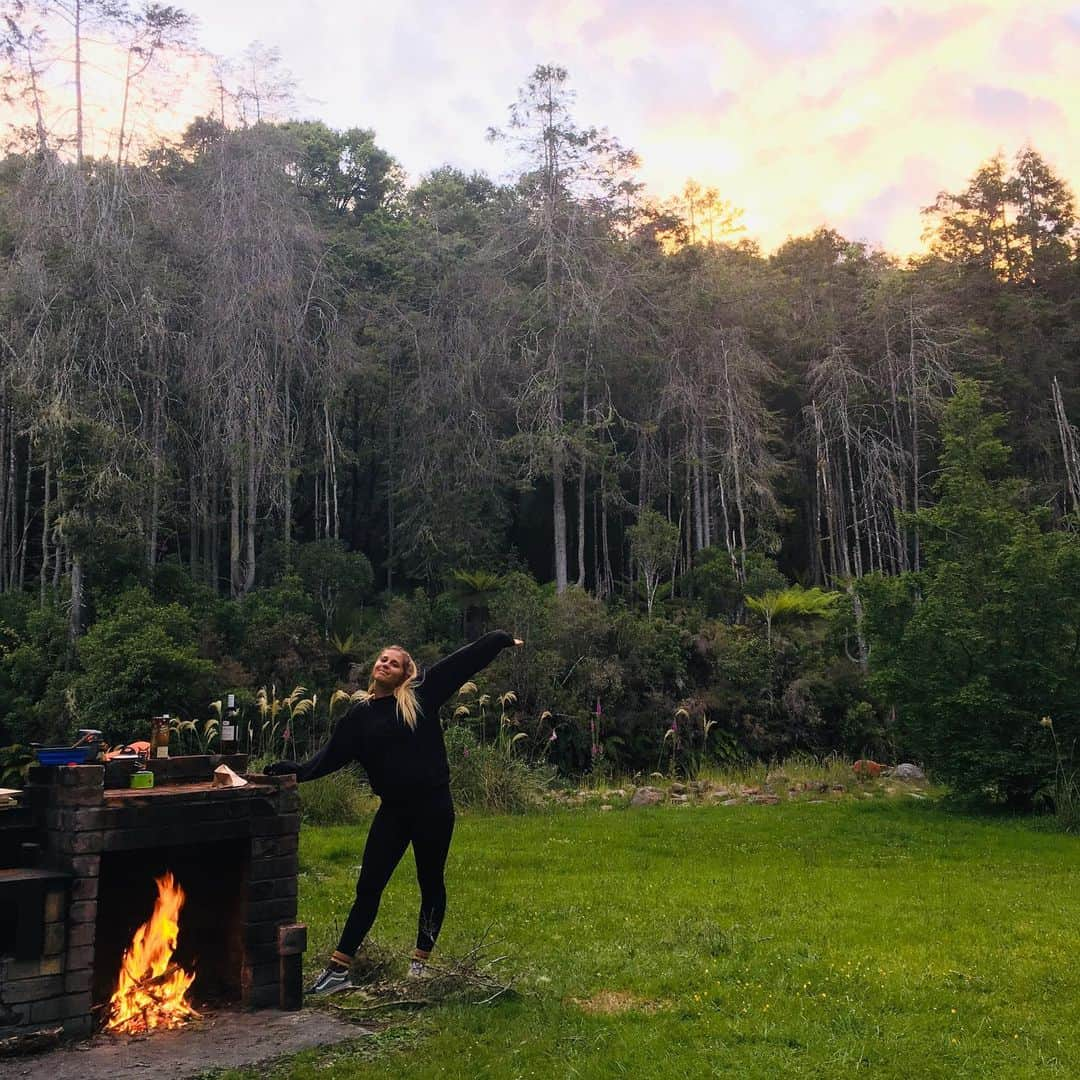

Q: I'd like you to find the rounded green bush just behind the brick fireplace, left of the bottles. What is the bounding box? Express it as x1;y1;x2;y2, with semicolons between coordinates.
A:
71;586;214;742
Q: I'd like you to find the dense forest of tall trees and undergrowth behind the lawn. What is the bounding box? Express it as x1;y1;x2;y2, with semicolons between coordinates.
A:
0;35;1080;808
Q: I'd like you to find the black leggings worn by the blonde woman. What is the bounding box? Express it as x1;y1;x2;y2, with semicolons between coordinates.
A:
337;787;454;956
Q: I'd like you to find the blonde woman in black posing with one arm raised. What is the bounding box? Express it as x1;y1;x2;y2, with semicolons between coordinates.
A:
267;630;523;995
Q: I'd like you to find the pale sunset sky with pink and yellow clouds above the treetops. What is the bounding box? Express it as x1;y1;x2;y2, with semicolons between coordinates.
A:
38;0;1080;255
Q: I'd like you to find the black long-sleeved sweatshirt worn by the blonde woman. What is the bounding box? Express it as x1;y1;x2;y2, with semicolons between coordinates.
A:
283;630;514;801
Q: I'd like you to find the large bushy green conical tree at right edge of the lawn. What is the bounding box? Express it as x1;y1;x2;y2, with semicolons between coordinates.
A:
861;383;1080;807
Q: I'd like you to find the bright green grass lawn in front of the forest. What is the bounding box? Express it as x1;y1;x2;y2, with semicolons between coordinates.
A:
223;799;1080;1080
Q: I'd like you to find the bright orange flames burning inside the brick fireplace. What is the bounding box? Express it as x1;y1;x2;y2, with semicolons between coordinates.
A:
105;872;199;1035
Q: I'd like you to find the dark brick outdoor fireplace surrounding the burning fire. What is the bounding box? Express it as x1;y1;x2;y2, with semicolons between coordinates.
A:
0;756;305;1039
